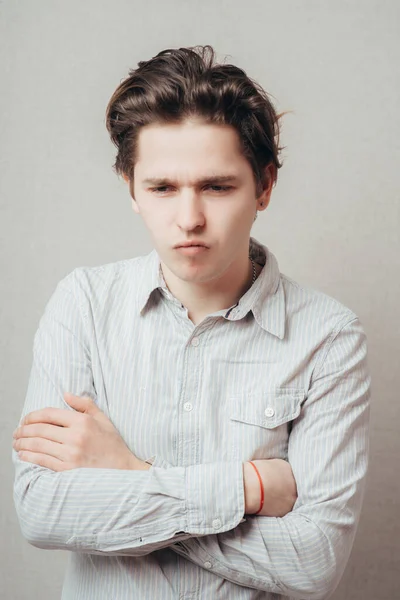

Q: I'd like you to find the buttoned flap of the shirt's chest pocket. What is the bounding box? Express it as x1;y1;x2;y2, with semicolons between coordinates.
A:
230;388;305;429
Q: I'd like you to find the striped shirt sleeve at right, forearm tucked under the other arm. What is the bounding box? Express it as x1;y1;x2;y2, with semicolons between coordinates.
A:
172;318;370;600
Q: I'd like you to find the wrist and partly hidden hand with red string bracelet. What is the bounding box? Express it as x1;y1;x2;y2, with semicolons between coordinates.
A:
243;458;297;517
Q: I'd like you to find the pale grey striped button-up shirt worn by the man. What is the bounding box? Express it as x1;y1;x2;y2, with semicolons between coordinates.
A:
13;238;370;600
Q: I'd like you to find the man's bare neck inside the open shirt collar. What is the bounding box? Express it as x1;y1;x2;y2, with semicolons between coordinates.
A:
161;255;259;325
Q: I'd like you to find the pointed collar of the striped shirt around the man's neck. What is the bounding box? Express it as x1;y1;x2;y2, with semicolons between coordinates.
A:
136;238;286;339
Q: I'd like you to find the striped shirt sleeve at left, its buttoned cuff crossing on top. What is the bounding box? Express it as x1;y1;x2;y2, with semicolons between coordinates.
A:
12;272;244;556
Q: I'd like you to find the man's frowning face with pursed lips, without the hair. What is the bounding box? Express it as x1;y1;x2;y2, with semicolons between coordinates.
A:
133;120;271;284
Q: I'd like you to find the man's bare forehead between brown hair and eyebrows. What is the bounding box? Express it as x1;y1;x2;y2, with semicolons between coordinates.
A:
135;120;250;178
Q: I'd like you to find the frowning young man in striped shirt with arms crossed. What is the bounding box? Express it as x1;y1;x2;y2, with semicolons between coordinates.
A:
13;47;369;600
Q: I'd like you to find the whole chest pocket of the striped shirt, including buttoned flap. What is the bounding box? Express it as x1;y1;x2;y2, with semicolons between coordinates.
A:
230;388;305;461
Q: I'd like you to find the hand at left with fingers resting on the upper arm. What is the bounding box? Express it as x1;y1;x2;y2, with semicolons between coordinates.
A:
13;393;150;471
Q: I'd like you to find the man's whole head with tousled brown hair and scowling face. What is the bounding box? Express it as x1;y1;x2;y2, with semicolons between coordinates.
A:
106;46;281;283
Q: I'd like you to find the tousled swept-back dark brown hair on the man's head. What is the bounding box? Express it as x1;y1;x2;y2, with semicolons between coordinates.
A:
106;45;281;195
